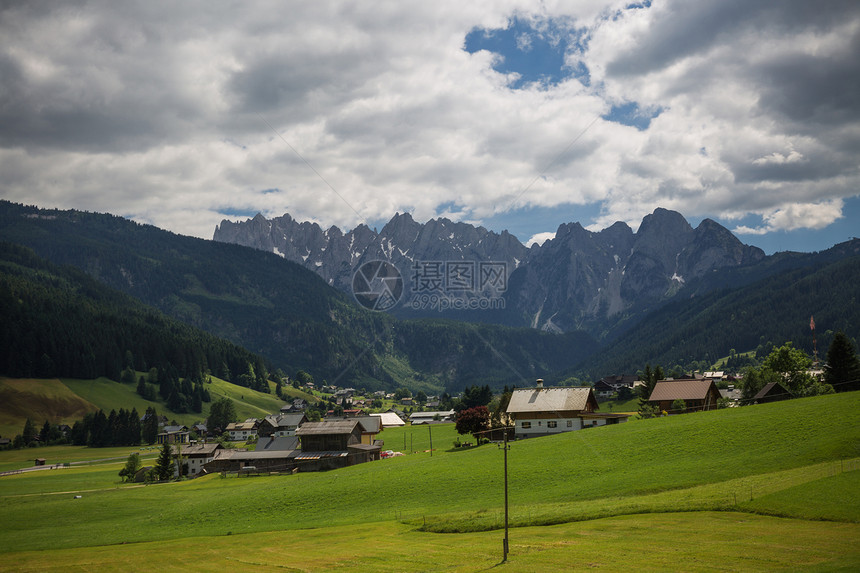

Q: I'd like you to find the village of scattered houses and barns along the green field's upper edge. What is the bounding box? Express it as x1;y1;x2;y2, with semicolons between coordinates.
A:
143;364;800;482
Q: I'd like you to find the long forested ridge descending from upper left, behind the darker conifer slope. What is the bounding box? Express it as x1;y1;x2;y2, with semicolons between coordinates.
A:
0;201;597;393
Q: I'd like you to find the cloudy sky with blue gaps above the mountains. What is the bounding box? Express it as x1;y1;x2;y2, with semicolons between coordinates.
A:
0;0;860;253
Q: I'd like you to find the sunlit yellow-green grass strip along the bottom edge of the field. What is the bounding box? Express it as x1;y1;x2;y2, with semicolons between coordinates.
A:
0;512;860;573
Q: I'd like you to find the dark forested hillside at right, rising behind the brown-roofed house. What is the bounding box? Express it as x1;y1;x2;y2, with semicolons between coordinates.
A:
556;247;860;379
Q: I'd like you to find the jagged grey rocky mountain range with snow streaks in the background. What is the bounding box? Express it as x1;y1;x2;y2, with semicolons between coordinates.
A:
214;208;765;332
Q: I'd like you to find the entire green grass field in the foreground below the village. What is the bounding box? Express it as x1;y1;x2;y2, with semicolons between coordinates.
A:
0;392;860;571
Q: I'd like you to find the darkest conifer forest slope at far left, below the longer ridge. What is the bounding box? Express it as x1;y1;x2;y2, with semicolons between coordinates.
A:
0;243;268;394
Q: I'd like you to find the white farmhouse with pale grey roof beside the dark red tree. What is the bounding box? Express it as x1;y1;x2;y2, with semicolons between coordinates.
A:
507;380;629;438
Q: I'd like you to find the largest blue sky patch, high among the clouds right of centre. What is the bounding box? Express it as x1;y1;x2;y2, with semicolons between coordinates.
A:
465;17;589;89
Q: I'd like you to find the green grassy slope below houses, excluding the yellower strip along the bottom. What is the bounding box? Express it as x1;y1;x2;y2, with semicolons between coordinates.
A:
0;392;860;570
